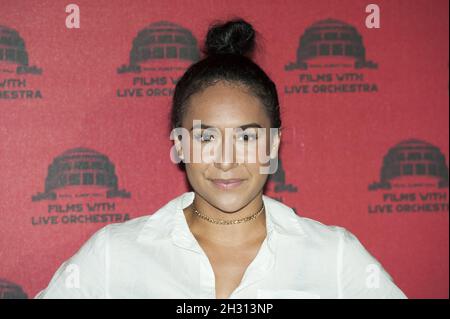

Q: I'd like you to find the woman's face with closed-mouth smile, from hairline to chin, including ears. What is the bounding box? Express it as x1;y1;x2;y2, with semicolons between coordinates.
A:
175;82;281;213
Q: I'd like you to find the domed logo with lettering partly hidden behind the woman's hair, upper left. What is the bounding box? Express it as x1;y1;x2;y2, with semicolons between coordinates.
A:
117;21;200;98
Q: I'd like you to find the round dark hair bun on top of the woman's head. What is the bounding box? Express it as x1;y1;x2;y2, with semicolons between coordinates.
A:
205;19;255;56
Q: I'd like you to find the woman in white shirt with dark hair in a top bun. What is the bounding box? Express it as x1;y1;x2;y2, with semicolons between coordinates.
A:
37;20;406;298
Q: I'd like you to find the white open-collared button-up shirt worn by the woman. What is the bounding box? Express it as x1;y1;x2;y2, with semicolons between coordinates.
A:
36;192;406;298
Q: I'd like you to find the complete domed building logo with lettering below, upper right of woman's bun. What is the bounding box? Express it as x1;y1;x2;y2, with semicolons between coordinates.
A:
284;18;378;94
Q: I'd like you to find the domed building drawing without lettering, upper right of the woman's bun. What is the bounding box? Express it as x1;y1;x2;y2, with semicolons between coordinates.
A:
285;18;378;71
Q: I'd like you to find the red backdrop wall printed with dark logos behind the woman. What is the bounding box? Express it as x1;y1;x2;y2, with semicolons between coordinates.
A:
0;0;449;298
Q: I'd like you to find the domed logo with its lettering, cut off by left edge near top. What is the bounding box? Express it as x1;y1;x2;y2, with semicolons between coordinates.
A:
0;25;42;100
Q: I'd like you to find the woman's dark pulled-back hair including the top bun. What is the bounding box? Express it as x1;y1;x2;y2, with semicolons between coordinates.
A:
171;19;281;129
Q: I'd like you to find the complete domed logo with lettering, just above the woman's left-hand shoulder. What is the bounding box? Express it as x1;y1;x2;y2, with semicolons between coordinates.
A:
32;147;131;225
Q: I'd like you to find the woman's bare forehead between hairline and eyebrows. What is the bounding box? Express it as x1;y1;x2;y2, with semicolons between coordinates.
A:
183;82;270;128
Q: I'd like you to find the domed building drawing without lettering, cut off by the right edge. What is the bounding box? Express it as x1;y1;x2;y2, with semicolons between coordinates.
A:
369;139;449;190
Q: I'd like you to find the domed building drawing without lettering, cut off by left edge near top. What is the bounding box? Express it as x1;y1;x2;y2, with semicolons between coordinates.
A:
0;25;42;74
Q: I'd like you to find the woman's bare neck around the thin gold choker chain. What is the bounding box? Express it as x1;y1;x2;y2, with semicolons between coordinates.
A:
184;191;266;246
